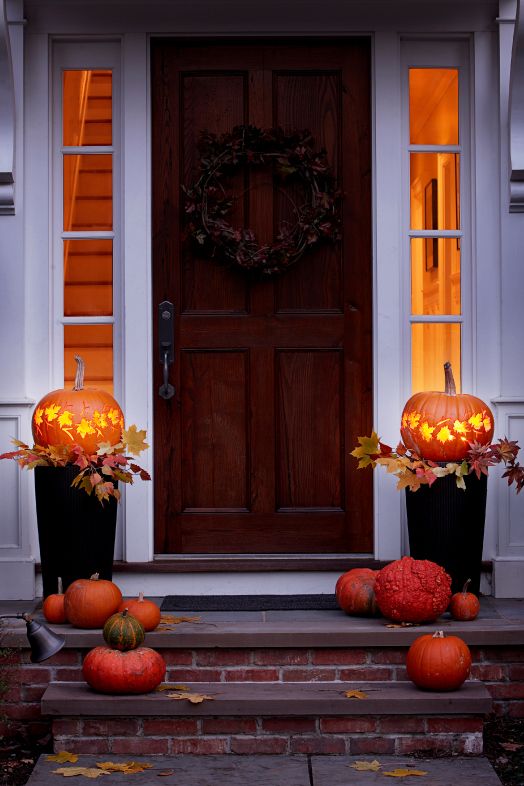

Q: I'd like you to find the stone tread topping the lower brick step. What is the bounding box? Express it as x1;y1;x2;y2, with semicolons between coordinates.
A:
42;680;492;717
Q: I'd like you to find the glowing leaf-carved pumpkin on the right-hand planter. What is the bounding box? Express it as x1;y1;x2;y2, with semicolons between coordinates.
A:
400;363;494;461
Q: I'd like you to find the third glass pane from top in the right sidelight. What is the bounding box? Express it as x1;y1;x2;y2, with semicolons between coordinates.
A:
411;237;461;314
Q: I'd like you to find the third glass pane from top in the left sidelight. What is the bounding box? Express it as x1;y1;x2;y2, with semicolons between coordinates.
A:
64;240;113;317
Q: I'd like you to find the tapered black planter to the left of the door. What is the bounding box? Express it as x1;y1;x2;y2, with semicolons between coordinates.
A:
35;465;118;598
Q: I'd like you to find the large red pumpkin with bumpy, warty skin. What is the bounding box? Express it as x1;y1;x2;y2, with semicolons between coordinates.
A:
375;557;451;622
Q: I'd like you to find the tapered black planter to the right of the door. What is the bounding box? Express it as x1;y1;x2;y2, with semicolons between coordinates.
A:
406;466;488;595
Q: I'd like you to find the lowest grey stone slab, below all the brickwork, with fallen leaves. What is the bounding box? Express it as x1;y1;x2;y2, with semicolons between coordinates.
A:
28;754;501;786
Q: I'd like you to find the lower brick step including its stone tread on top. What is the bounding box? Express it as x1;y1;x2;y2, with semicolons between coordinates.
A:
42;681;491;755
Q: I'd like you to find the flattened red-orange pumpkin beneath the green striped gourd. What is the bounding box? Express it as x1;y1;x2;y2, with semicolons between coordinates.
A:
82;647;166;694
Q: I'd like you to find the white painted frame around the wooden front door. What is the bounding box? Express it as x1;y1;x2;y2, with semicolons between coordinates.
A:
119;33;404;570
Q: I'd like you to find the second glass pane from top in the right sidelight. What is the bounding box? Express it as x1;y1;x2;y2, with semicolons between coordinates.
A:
410;153;460;229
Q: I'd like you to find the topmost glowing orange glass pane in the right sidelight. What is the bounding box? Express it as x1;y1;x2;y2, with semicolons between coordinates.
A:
409;68;459;145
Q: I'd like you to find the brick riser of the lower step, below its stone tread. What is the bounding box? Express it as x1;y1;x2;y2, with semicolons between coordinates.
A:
52;716;483;755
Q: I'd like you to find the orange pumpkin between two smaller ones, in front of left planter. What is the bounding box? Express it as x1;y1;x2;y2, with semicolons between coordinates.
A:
64;573;122;628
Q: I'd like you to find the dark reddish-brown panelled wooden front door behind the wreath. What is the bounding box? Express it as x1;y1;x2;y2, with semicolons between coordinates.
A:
152;39;372;554
